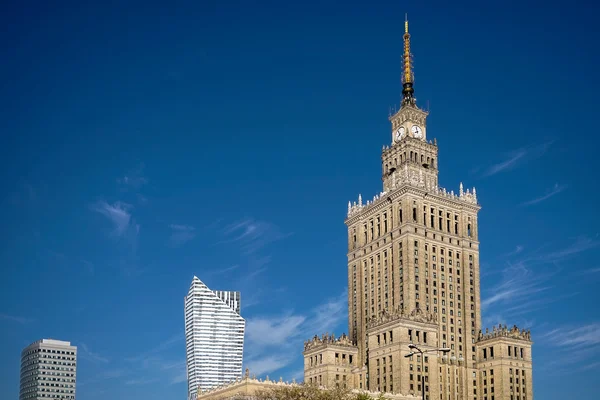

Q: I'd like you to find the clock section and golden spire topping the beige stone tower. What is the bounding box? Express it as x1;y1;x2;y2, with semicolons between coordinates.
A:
381;21;438;192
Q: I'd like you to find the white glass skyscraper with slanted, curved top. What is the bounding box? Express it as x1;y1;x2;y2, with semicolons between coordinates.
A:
185;276;246;400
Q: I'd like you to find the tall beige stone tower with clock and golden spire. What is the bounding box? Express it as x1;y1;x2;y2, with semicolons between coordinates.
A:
304;15;533;400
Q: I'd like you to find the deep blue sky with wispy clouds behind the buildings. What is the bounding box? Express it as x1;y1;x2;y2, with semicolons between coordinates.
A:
0;1;600;400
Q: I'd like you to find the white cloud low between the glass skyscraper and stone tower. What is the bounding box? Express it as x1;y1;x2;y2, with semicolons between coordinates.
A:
244;291;348;375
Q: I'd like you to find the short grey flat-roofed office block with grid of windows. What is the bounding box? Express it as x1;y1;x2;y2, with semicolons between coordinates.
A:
19;339;77;400
